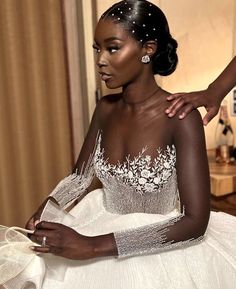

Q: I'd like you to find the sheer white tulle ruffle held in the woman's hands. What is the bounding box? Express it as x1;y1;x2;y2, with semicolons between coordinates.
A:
0;201;74;289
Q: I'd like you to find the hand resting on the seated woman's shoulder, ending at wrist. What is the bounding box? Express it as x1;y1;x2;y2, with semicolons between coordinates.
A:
166;89;221;125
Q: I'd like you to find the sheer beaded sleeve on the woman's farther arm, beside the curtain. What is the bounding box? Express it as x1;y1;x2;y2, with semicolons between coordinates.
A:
50;104;99;208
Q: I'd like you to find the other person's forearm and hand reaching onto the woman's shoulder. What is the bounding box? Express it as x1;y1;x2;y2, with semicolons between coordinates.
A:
166;56;236;125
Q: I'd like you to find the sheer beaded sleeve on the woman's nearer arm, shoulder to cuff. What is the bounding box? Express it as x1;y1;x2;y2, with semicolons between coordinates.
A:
114;111;210;257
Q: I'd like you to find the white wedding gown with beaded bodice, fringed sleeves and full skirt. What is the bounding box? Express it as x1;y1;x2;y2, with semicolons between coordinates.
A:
0;133;236;289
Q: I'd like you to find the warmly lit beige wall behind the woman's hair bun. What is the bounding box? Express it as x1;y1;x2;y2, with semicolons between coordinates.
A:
93;0;236;148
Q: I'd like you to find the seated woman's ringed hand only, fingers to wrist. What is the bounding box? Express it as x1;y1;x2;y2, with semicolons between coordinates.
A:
31;221;95;260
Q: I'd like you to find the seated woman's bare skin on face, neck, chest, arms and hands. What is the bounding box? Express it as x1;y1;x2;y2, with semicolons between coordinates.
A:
26;20;209;260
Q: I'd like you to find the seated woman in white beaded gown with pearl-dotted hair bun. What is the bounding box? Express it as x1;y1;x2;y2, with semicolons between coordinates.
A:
0;0;236;289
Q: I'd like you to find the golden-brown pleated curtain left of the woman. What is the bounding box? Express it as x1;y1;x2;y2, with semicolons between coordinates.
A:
0;0;73;226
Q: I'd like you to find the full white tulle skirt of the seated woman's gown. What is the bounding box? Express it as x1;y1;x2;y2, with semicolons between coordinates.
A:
1;189;236;289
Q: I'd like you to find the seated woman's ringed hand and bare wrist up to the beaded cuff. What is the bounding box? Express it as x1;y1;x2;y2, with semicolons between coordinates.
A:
31;221;117;260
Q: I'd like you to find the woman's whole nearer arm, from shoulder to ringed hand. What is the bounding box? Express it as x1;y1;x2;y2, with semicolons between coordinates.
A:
31;111;210;260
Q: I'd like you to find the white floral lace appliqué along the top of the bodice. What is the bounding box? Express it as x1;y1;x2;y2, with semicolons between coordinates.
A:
94;135;176;194
